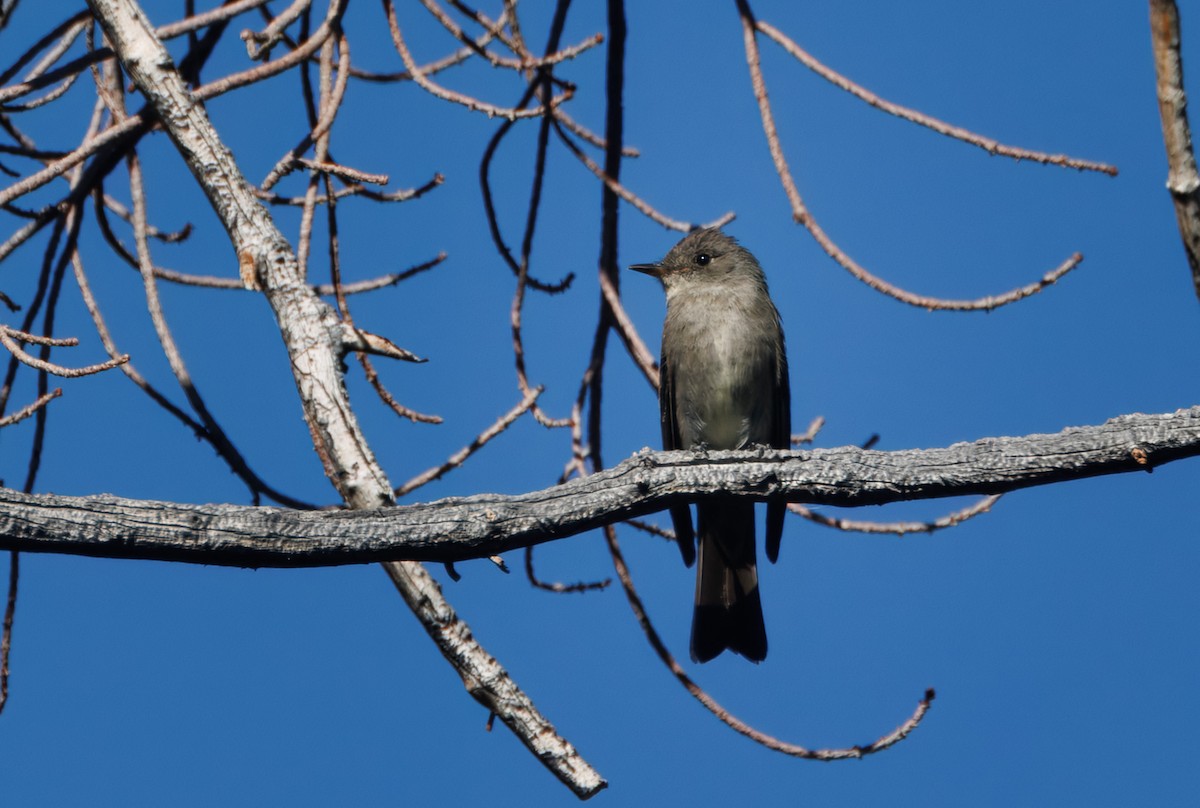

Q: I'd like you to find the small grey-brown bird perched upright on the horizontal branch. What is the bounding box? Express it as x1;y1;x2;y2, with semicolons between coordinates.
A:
630;229;792;662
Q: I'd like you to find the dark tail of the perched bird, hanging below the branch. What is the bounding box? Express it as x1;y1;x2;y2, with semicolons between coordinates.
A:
691;501;767;662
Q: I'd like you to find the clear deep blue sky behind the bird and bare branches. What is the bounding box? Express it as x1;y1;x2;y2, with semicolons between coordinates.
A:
0;0;1200;806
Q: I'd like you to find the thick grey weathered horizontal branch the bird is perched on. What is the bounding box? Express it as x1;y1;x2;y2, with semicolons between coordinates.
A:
0;407;1200;567
